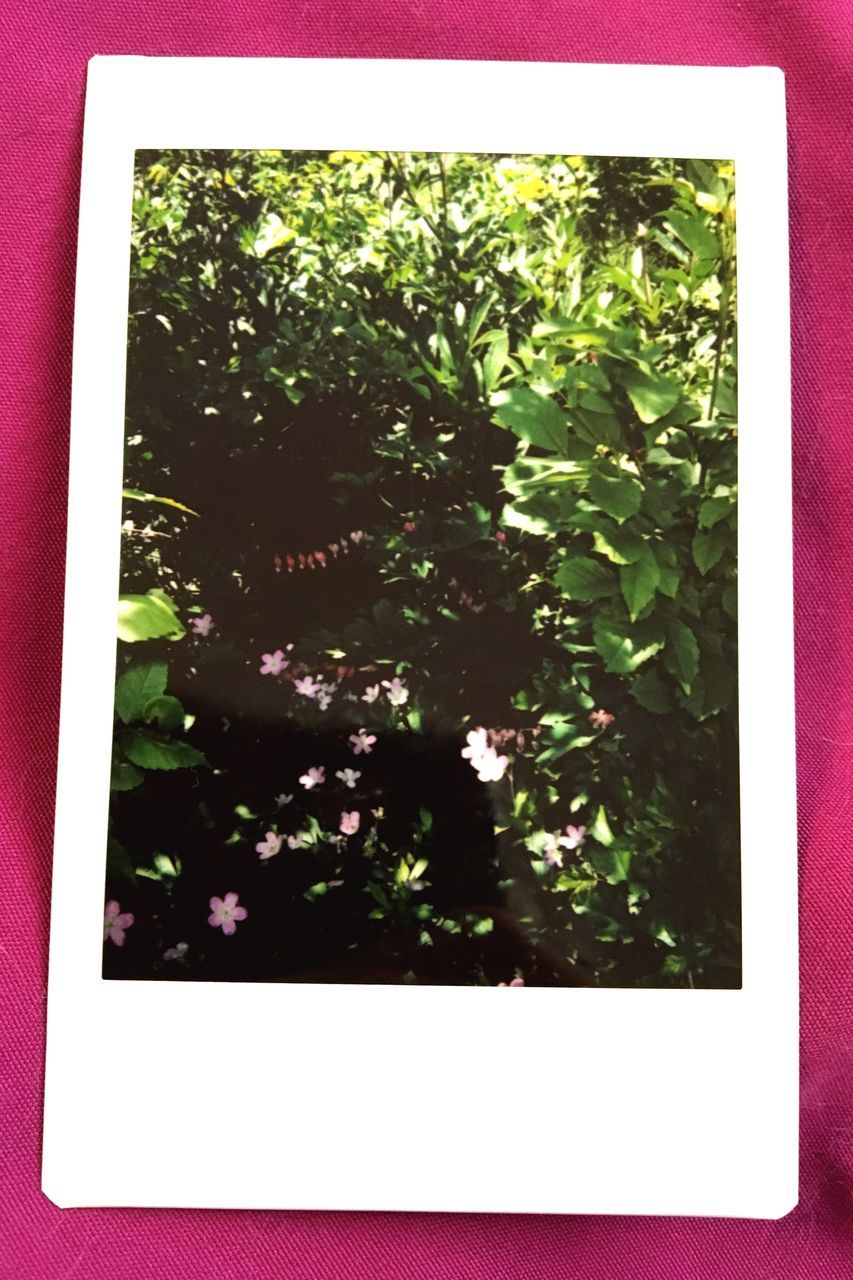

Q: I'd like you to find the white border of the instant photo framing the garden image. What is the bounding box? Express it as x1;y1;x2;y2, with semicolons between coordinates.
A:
42;58;798;1217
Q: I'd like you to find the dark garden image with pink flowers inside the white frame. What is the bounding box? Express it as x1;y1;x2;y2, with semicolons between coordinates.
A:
103;150;742;1000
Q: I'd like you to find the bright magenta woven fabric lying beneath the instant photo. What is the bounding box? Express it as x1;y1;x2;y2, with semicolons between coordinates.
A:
0;0;853;1280
